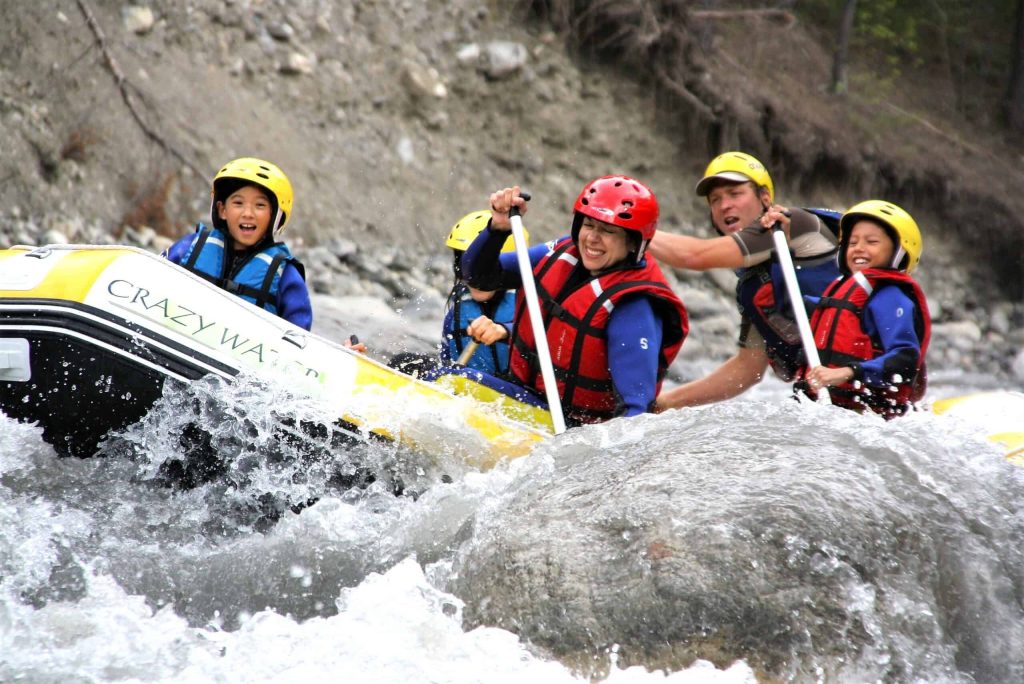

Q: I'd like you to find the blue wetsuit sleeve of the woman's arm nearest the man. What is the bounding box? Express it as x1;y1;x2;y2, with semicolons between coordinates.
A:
608;296;663;416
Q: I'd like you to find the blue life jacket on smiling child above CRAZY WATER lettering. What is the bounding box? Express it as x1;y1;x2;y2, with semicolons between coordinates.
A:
181;223;305;315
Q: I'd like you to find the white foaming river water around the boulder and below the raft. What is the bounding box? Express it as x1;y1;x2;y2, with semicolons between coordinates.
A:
0;368;1024;684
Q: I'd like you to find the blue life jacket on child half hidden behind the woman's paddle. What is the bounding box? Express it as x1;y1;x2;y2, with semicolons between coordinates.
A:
441;283;515;375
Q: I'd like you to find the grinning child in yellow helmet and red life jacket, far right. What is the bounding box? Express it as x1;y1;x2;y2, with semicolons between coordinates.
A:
797;200;932;418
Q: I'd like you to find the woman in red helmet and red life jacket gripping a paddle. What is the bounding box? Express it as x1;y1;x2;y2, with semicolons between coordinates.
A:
463;176;688;425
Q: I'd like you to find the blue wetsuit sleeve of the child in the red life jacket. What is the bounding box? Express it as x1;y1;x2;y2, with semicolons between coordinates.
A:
858;286;921;387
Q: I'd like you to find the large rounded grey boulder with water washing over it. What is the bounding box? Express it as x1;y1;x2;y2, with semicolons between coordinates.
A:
453;402;1024;682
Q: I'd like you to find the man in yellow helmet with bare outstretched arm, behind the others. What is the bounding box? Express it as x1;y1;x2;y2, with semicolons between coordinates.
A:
650;152;840;411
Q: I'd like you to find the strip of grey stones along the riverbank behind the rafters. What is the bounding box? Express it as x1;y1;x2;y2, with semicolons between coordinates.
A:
0;217;1024;395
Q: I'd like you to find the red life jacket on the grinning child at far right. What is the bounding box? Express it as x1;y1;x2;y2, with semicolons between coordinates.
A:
811;268;932;418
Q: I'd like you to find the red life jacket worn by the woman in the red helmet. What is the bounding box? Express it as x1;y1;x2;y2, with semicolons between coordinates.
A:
509;238;689;424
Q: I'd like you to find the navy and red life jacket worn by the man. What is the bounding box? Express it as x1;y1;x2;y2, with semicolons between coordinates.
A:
736;209;842;382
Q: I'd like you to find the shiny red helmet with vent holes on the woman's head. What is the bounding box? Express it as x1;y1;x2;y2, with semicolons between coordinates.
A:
572;176;657;244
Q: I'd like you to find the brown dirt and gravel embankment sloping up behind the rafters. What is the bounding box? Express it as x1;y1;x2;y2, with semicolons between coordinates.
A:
0;0;1024;376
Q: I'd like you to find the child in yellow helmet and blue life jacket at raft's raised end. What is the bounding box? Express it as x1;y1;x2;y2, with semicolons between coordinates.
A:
159;157;313;330
